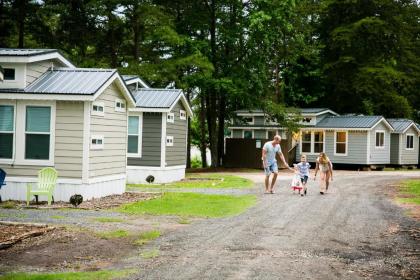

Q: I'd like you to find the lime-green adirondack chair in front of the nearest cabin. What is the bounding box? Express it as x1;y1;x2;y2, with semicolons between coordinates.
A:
26;167;57;205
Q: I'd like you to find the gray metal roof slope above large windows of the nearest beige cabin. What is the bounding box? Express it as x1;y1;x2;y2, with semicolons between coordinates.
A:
24;68;117;94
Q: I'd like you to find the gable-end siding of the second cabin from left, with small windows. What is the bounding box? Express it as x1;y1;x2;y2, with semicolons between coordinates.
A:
166;101;188;166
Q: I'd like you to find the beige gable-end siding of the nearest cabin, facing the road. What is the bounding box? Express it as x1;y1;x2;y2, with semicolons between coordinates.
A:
89;83;128;178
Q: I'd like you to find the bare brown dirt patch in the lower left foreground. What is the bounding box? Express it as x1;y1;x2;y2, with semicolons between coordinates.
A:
0;228;136;271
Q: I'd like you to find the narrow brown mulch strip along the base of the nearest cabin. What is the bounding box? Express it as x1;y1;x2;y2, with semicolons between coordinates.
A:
6;192;160;210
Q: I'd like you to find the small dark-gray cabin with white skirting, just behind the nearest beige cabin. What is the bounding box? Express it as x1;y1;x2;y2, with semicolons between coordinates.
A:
127;88;193;184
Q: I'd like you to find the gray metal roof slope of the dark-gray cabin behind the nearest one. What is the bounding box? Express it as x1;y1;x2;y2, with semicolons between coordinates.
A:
133;88;182;108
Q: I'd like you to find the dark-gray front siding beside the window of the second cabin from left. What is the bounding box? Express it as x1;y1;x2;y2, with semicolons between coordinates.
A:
127;113;162;166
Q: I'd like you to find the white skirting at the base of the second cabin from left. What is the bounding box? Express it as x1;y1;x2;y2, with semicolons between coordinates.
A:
127;165;185;184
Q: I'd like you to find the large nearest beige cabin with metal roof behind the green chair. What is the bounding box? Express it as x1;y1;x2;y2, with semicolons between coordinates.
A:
0;49;136;201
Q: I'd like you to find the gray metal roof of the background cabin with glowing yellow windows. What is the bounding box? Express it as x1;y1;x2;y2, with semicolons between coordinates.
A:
315;116;382;128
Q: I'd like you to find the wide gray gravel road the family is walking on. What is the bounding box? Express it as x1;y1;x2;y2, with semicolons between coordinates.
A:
127;172;420;279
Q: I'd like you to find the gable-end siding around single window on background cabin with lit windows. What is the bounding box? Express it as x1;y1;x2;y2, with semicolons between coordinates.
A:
369;122;391;164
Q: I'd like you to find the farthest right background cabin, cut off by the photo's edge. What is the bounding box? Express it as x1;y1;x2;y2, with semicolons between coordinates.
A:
387;119;420;165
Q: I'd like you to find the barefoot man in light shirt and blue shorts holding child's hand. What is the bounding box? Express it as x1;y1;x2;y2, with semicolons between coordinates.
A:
261;135;293;193
